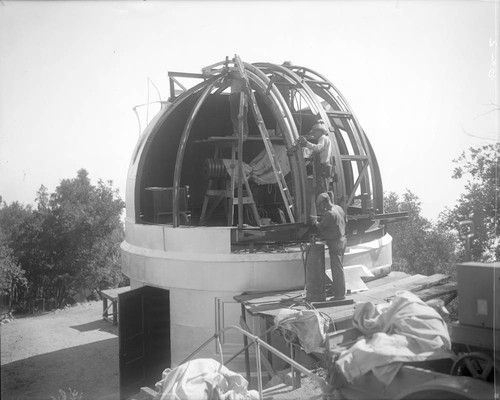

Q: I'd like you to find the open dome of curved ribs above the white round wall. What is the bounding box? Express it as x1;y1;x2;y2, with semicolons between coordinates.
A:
133;56;397;250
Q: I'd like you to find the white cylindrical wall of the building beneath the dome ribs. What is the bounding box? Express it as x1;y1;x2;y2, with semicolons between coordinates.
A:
121;221;392;364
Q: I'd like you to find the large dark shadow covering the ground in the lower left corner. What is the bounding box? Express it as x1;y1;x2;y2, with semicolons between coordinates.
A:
1;338;119;400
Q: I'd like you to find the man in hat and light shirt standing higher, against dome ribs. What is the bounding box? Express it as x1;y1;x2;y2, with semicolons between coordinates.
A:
298;123;332;193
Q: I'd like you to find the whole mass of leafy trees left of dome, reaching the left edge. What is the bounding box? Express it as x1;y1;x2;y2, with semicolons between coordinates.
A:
0;169;124;307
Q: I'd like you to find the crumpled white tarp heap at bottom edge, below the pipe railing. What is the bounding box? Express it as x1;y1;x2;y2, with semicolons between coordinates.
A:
155;358;259;400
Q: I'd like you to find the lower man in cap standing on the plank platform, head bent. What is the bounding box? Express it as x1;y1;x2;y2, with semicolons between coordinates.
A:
313;193;347;300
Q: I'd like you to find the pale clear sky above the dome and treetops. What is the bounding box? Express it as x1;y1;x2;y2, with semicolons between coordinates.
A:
0;0;500;219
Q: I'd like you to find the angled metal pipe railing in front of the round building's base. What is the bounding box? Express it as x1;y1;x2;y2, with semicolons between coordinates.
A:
179;326;326;400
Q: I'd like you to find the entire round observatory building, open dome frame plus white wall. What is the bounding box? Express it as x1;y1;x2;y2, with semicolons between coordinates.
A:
121;56;399;364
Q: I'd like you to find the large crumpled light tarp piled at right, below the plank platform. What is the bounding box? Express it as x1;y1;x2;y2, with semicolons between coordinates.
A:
336;291;454;384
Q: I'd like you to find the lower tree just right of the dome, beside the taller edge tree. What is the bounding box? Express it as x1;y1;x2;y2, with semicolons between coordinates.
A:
384;190;457;275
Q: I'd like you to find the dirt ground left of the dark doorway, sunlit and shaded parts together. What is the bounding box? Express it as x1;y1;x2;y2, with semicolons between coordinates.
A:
0;301;119;400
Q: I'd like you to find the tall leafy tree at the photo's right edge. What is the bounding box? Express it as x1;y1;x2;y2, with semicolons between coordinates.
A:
440;143;500;261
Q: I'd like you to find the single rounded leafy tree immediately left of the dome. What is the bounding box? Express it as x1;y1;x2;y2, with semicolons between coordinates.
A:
44;169;125;299
